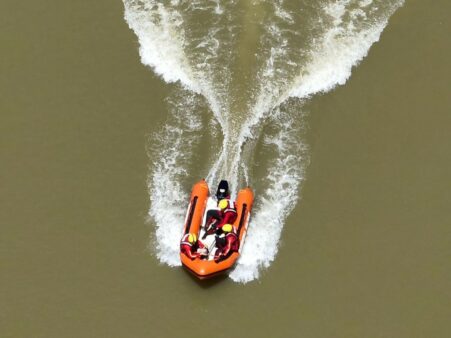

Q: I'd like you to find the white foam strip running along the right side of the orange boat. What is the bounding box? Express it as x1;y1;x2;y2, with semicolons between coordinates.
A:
230;105;308;282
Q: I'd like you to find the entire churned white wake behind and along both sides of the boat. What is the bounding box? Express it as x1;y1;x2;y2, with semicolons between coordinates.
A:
124;0;403;282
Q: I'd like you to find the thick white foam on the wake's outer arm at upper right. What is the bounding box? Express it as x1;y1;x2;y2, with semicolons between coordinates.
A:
289;0;402;98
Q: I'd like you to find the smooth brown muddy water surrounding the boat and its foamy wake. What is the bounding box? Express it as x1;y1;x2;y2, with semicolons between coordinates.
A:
0;0;451;338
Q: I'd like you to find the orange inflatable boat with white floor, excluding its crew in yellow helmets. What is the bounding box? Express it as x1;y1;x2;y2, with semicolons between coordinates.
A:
180;180;254;279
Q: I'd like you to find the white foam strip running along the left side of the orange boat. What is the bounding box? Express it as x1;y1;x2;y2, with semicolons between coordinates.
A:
148;91;202;266
